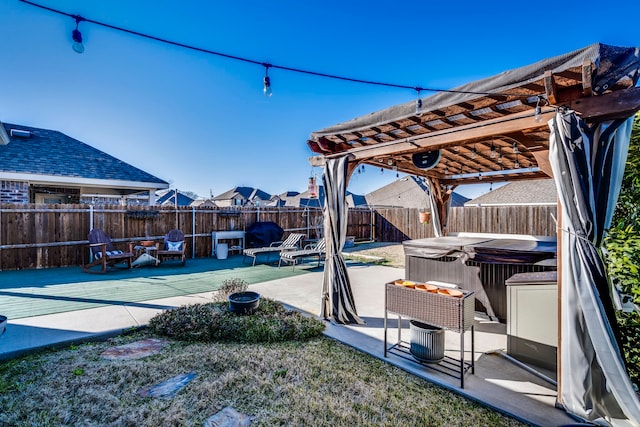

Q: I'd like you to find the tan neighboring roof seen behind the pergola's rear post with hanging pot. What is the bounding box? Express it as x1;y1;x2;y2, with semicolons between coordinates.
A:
365;176;469;210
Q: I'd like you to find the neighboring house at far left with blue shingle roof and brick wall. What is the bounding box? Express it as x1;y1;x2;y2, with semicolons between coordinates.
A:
0;122;169;205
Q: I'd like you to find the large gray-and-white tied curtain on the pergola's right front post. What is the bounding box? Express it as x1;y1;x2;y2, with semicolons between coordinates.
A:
549;111;640;426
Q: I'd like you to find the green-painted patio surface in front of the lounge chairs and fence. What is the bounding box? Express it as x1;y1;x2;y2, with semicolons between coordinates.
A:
0;255;315;320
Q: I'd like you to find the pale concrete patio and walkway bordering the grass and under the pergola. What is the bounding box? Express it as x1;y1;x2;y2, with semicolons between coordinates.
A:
0;256;576;426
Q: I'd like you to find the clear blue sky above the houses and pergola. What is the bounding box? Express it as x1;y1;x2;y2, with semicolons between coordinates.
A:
0;0;640;201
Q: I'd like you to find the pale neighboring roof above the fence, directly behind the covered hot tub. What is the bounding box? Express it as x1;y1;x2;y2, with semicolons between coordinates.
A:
464;179;558;206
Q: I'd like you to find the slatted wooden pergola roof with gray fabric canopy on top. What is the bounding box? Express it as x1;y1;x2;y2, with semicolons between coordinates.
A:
307;43;640;186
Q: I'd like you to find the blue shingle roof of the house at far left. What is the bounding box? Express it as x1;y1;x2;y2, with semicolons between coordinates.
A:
0;123;168;185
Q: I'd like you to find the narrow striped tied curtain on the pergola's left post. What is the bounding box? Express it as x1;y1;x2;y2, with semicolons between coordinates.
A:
322;156;364;324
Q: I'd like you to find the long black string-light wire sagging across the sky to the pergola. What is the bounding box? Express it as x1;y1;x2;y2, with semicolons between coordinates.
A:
19;0;539;98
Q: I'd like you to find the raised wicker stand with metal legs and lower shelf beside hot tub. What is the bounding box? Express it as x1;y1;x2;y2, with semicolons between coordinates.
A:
384;282;475;388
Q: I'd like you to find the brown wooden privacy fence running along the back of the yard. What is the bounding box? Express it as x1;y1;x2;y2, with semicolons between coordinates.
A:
0;204;556;271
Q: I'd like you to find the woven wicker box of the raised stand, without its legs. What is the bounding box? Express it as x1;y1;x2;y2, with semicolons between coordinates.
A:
385;283;475;332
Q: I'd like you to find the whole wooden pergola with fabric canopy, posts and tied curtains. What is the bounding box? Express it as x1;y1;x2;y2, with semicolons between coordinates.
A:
307;43;640;422
